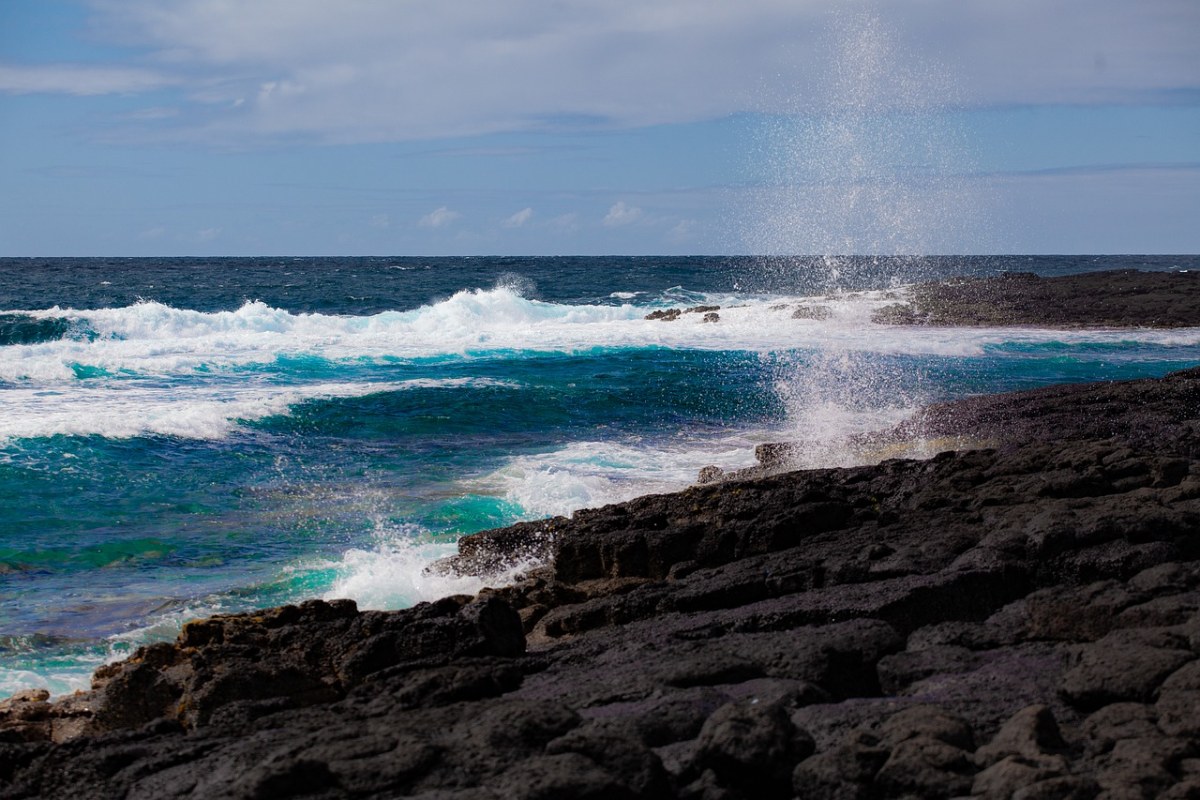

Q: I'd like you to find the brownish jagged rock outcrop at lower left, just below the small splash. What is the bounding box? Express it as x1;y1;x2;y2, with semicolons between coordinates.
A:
70;597;524;732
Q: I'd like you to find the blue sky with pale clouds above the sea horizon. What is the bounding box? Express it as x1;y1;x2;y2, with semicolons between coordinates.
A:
0;0;1200;257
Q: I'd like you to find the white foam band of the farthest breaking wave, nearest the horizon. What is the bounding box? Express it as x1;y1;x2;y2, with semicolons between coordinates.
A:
0;288;1198;386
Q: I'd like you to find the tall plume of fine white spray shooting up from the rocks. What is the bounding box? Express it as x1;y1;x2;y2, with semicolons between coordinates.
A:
746;13;977;465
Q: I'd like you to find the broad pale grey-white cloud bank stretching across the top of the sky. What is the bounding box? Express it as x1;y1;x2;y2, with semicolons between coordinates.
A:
18;0;1200;142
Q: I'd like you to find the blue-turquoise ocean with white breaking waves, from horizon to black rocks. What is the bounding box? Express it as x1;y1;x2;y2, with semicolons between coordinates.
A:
0;255;1200;697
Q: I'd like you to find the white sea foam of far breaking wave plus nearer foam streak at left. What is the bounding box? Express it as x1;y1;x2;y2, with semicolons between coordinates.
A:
0;287;1200;441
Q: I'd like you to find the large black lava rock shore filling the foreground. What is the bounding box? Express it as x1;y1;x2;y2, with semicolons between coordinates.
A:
7;369;1200;800
